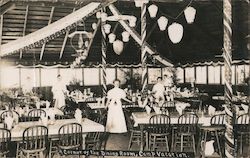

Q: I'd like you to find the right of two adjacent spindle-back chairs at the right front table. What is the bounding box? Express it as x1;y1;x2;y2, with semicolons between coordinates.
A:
172;113;199;153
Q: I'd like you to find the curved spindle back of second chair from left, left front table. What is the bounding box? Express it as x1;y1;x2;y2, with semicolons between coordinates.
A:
22;125;48;151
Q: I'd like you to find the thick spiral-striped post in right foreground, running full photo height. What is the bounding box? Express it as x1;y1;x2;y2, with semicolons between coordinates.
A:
223;0;237;158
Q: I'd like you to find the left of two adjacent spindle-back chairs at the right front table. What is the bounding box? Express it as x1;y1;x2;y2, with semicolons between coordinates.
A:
147;114;171;151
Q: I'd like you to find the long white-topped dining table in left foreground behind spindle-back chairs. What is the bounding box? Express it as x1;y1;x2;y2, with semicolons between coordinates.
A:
0;118;105;149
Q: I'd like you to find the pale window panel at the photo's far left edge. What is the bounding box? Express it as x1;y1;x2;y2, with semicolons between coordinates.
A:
0;66;20;88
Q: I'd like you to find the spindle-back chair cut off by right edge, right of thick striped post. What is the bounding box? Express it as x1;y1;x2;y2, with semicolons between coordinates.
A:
236;113;250;155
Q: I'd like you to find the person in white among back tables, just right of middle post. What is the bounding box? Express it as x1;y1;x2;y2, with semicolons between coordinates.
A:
152;77;165;103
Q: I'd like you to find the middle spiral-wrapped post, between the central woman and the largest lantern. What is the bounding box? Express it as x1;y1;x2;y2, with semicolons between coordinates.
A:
141;3;148;92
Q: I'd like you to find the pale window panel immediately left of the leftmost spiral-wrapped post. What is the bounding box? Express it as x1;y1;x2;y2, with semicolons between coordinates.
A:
83;68;99;86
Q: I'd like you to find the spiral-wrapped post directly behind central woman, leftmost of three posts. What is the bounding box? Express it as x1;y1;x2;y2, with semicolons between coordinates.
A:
101;9;107;96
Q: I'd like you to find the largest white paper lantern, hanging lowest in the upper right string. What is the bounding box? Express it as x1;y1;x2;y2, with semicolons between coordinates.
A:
168;23;183;43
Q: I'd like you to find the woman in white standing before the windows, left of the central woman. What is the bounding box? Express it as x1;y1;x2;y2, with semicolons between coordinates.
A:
52;75;67;109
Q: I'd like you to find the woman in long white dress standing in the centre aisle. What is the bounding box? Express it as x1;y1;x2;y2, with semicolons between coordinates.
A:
106;79;131;133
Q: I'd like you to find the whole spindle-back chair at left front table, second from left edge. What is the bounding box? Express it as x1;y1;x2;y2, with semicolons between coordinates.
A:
20;125;48;158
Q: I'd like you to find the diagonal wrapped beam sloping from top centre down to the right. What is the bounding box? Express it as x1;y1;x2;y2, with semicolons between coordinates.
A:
109;4;173;67
